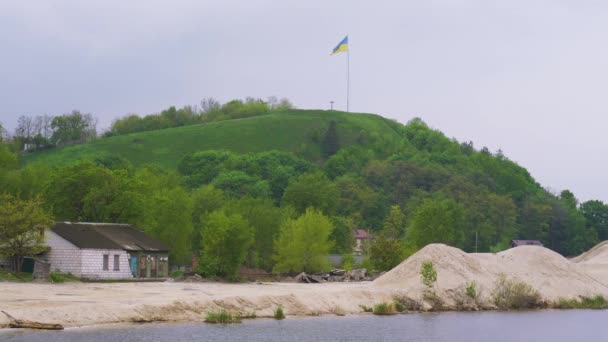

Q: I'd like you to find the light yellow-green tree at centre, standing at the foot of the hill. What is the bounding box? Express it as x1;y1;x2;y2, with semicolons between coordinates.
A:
273;208;334;273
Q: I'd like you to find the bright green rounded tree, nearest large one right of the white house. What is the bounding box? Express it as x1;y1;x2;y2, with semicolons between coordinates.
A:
200;210;253;279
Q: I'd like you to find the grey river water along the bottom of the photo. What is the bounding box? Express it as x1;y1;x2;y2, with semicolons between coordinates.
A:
0;310;608;342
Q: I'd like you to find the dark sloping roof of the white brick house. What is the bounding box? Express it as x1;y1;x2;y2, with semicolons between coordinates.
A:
51;222;169;252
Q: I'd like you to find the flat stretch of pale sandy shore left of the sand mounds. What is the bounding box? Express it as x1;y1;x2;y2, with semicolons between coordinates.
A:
0;282;391;326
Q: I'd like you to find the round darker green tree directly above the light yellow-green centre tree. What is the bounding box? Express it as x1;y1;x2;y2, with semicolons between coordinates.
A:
283;172;338;215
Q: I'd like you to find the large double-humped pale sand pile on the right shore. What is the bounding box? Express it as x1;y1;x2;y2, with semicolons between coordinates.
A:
374;244;608;300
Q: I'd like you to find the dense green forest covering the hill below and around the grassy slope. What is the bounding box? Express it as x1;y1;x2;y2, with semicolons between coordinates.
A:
0;99;608;278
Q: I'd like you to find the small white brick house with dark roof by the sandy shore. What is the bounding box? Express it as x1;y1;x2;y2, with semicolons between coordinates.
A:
44;222;169;279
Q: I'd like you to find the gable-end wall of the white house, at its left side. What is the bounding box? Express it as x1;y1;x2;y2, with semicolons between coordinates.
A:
44;230;82;277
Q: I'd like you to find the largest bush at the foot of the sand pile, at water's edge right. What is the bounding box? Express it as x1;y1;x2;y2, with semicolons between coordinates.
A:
492;274;543;310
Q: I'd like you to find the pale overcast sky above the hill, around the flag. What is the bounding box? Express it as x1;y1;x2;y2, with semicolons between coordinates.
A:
0;0;608;201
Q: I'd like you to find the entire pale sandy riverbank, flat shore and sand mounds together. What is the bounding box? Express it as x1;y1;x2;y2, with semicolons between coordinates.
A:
0;244;608;327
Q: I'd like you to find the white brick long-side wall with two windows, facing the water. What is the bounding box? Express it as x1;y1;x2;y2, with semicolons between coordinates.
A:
80;249;132;279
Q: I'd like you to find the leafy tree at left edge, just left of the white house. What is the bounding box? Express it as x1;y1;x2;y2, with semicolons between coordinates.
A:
0;194;53;272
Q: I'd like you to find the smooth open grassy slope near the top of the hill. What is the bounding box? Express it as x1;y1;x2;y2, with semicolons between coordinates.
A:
22;110;399;168
